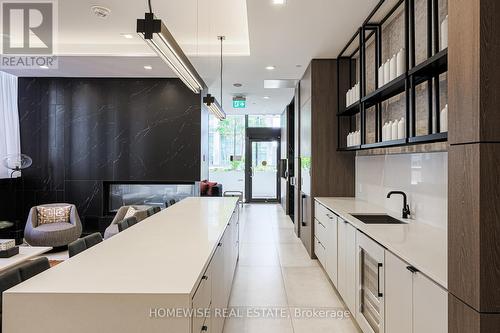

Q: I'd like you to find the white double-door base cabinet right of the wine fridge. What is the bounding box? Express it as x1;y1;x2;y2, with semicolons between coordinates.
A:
385;251;448;333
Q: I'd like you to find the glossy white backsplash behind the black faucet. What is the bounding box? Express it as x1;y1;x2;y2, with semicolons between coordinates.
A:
356;152;448;229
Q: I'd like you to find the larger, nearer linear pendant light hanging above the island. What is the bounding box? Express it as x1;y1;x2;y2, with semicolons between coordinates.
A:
137;0;206;94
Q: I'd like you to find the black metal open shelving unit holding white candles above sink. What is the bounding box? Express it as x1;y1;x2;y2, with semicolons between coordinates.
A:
337;0;448;151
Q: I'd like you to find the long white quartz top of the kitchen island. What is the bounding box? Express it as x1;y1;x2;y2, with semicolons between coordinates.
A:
7;198;237;294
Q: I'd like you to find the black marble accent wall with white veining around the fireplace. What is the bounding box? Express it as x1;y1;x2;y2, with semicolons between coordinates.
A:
13;78;208;228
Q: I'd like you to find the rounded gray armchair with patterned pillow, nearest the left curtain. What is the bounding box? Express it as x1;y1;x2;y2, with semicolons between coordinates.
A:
24;204;82;247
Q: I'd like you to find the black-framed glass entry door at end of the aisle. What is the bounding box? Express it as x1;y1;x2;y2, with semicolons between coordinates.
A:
248;139;279;202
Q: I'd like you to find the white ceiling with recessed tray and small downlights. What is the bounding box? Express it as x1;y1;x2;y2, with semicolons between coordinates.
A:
1;0;378;114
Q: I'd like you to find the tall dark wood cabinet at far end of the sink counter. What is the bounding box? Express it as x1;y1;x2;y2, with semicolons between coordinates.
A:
296;59;355;257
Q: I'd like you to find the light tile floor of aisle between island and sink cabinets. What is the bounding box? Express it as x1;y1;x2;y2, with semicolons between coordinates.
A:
224;204;359;333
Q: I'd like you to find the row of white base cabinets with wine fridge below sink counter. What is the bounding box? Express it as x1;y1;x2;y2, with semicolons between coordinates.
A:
314;201;448;333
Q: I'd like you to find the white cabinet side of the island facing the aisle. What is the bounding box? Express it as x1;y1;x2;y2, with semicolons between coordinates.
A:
191;208;239;333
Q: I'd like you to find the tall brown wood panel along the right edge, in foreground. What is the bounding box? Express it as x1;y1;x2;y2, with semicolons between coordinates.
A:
448;0;500;326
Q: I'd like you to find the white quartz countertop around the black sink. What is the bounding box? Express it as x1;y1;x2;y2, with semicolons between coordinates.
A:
315;198;448;289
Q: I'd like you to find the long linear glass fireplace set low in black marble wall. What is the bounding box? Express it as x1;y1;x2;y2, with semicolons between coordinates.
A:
103;181;200;215
